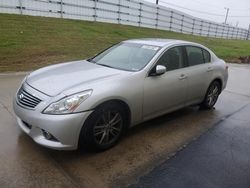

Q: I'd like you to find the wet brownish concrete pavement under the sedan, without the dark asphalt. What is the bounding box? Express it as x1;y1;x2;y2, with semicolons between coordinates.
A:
0;64;250;187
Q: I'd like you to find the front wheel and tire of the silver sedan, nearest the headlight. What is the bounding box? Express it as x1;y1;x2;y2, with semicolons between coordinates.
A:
79;102;126;151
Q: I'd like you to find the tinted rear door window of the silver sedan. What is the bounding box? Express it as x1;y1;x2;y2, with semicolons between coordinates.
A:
186;46;204;66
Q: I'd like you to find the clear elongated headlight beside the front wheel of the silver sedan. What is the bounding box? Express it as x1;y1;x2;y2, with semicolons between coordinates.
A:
43;90;92;114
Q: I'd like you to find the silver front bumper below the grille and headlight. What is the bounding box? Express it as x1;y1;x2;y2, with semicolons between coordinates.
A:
13;99;92;150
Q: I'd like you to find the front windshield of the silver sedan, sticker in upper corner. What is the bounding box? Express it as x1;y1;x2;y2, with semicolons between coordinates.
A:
89;43;160;71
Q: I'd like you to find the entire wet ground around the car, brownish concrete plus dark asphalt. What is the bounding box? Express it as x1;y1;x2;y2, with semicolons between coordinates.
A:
0;64;250;187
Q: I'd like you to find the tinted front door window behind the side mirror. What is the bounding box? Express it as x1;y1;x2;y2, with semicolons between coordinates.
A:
157;47;184;71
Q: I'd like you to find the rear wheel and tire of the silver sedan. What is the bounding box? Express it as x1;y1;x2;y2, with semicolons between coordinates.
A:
200;81;221;109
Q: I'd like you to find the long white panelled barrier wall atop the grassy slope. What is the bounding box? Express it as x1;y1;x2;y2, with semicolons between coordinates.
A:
0;0;250;40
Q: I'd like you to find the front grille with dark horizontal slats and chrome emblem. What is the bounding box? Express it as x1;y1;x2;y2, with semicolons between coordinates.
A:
17;87;42;108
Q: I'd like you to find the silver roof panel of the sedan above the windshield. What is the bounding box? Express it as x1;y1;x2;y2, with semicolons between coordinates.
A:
124;38;197;47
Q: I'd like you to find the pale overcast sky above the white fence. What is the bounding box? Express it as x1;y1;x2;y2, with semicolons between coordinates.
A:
146;0;250;28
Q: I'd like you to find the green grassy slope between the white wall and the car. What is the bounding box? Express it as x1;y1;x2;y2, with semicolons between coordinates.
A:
0;14;250;72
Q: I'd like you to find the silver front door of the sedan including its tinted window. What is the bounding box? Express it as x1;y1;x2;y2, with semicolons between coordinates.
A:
143;47;187;120
